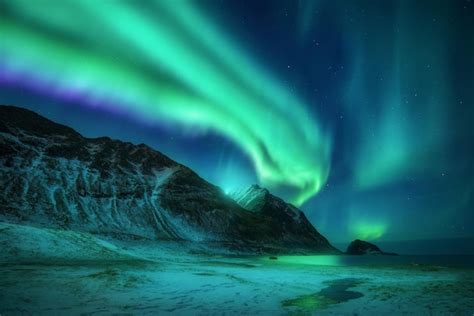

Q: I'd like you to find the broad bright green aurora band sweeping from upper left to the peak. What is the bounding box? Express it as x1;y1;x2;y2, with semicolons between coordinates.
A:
0;0;331;205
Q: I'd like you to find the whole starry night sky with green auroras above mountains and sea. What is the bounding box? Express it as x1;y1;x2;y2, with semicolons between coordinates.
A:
0;0;474;242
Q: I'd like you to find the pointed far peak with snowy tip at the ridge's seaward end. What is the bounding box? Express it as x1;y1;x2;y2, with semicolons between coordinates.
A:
231;185;339;253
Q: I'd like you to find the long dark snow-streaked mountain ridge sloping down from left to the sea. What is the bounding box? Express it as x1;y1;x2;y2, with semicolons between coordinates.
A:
0;106;334;252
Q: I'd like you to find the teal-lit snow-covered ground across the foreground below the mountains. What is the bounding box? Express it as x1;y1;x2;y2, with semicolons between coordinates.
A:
0;224;474;315
